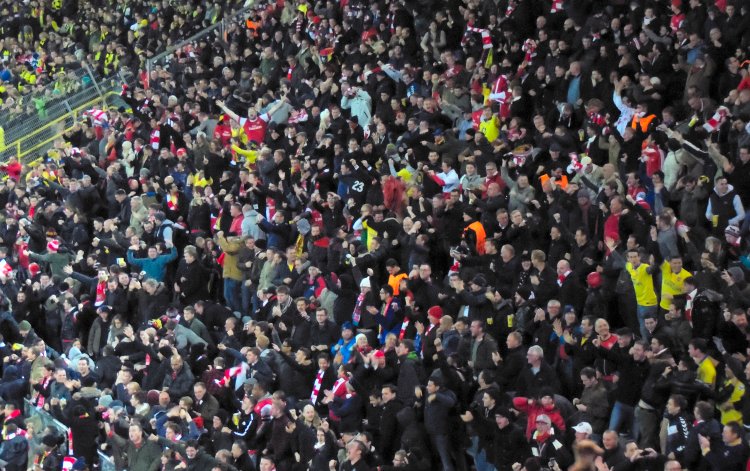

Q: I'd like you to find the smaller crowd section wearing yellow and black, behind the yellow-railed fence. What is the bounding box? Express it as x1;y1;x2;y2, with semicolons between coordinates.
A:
0;0;243;125
